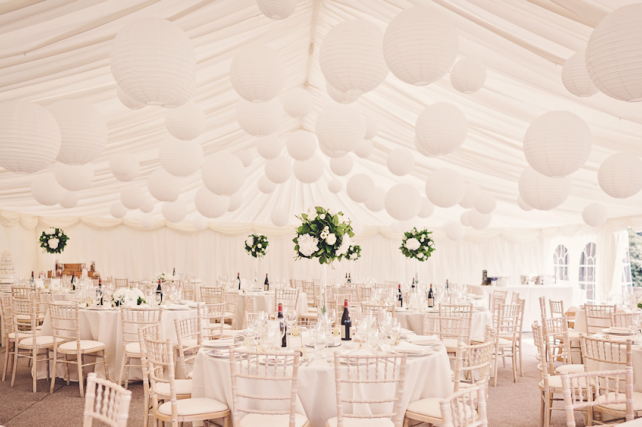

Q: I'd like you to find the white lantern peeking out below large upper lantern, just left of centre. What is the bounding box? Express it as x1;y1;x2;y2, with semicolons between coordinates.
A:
236;98;283;136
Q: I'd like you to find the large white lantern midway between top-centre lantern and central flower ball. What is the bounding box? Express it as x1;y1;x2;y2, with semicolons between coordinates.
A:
316;104;366;157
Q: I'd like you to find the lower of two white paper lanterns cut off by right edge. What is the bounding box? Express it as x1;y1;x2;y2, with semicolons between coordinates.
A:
597;153;642;199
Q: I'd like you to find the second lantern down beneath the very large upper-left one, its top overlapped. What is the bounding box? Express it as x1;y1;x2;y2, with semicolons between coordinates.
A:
159;136;205;177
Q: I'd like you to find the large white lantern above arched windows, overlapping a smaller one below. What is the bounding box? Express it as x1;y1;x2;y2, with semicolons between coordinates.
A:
524;111;591;178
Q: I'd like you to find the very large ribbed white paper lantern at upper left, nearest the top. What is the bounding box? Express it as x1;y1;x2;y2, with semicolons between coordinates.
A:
109;16;196;108
